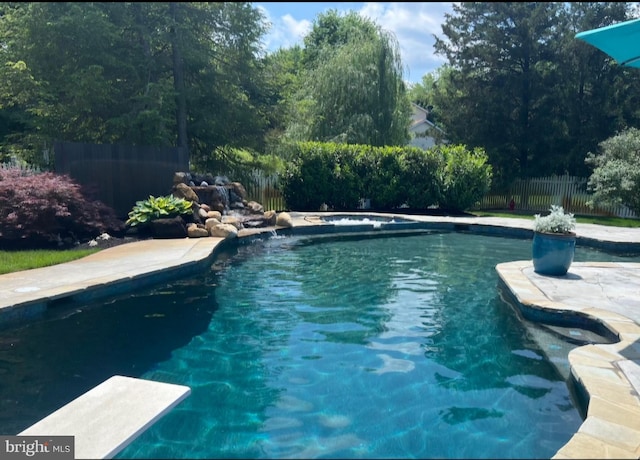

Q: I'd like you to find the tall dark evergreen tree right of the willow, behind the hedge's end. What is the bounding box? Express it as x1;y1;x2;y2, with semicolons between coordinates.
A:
435;2;558;183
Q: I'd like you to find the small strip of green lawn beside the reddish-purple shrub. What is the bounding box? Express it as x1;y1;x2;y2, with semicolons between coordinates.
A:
0;249;99;275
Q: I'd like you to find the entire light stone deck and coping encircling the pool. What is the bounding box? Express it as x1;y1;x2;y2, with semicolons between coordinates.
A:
0;213;640;459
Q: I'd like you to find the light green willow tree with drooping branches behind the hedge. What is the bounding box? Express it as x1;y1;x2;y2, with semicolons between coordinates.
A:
287;11;411;146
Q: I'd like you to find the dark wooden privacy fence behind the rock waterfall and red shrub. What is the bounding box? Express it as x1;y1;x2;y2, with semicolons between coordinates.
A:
53;142;189;218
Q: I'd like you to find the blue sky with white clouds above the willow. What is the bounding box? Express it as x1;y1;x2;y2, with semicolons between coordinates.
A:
253;2;453;83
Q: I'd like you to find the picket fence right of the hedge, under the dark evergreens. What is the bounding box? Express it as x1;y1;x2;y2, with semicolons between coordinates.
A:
475;175;638;217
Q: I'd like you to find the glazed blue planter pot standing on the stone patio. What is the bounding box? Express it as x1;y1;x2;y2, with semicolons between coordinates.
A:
532;232;576;276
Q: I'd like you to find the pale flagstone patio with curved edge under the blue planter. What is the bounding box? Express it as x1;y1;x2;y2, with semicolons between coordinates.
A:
496;261;640;459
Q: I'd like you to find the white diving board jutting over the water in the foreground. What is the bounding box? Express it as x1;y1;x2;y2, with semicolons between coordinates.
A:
18;375;191;459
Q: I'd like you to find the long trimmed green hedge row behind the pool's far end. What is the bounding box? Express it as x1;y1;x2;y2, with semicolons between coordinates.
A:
281;142;492;211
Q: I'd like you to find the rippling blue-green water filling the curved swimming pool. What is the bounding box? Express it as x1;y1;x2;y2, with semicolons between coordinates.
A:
0;232;638;458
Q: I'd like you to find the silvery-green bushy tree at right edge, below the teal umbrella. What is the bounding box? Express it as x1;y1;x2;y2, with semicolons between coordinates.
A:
585;128;640;214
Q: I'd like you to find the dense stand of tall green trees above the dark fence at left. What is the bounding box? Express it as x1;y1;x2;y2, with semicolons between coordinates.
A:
0;2;272;167
